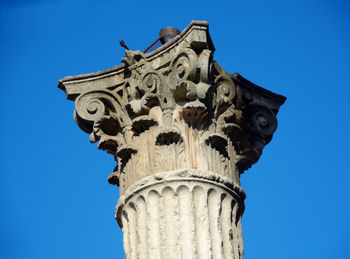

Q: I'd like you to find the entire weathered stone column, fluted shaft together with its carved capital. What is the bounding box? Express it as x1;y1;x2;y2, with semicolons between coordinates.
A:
59;21;285;259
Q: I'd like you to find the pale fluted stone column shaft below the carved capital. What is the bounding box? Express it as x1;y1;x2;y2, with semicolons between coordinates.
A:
116;170;245;259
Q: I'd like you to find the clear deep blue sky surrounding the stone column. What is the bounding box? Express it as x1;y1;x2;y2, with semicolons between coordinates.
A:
0;0;350;259
